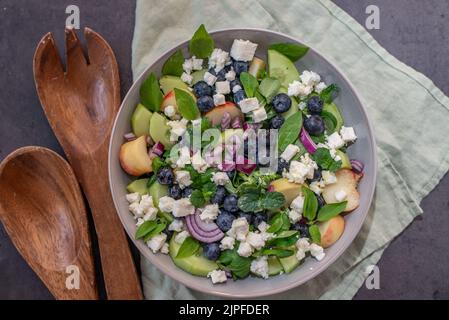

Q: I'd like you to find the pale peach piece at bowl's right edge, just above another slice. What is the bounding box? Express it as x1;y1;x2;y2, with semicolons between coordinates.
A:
323;169;362;212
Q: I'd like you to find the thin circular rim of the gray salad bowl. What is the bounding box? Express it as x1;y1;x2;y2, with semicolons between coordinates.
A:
108;28;378;298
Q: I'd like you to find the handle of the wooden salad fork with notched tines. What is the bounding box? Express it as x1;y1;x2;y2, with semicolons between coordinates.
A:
81;163;143;300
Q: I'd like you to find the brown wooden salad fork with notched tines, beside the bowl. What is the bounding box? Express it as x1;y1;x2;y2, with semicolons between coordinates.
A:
34;28;142;299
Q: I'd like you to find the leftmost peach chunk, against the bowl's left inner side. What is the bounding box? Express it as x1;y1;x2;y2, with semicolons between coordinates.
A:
119;136;153;177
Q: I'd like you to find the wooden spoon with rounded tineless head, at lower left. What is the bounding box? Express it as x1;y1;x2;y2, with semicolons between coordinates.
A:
0;147;98;300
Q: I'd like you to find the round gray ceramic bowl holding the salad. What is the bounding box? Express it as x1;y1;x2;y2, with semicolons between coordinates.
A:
109;29;376;298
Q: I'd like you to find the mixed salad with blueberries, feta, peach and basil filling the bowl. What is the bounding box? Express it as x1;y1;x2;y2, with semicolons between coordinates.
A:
115;26;364;284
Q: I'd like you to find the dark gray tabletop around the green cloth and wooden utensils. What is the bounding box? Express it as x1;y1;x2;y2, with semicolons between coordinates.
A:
0;0;449;299
